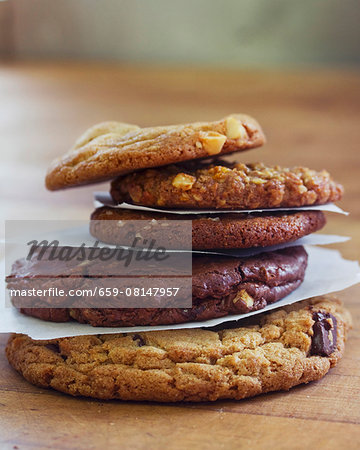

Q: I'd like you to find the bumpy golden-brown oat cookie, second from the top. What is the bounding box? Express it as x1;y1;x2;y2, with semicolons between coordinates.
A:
111;161;343;210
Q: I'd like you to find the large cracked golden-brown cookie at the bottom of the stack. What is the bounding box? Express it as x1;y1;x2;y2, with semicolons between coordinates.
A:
6;297;351;402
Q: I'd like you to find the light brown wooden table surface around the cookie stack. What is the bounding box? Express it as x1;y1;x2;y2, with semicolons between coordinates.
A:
0;62;360;449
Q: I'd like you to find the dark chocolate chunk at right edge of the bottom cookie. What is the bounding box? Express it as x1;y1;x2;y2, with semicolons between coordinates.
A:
310;311;337;356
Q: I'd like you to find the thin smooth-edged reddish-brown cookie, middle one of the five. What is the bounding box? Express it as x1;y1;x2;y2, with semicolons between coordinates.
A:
90;206;326;250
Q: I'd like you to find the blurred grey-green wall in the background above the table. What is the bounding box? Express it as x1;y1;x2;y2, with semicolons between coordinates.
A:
0;0;360;67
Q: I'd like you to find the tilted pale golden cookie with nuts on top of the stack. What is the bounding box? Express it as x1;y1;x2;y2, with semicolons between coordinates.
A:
46;114;265;190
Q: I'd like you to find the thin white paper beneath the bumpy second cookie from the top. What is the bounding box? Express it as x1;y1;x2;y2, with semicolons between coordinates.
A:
94;191;349;216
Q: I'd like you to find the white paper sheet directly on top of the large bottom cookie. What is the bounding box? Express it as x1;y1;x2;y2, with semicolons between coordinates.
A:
0;246;360;340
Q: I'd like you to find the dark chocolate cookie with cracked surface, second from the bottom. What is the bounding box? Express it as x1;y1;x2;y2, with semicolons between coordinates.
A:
7;246;307;327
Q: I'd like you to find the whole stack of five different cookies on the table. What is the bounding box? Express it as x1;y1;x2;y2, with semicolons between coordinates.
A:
7;114;350;401
